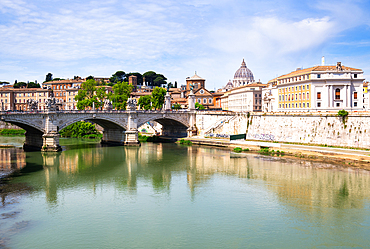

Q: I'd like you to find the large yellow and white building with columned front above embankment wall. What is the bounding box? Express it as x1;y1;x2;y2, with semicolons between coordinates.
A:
276;62;364;111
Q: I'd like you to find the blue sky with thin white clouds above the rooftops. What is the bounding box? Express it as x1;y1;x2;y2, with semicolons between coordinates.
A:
0;0;370;90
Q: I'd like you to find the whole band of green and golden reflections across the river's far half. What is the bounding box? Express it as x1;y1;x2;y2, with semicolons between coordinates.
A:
10;144;370;211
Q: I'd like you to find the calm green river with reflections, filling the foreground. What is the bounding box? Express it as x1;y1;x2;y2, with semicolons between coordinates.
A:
0;138;370;248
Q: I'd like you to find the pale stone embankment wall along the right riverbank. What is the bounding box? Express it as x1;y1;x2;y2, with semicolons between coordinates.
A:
202;113;370;149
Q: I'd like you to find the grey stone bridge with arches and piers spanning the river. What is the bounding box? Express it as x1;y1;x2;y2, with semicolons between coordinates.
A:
0;110;195;151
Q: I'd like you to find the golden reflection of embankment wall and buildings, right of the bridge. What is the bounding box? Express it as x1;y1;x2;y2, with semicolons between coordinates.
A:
187;147;370;208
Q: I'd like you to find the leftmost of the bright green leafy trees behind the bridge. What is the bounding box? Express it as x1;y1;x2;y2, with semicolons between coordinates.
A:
75;79;101;110
